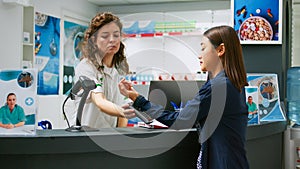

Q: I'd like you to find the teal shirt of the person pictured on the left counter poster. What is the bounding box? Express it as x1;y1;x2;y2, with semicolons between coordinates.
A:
0;104;26;124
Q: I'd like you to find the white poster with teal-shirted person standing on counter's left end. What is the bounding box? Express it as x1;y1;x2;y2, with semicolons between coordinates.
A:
0;69;37;135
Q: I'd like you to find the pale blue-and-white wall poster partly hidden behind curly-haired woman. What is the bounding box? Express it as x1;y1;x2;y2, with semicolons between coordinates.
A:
63;21;87;94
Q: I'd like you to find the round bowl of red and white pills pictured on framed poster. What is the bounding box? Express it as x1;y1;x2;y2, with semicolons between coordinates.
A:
239;16;273;41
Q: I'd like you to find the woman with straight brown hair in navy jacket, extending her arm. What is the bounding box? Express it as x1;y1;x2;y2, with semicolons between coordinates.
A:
119;26;249;169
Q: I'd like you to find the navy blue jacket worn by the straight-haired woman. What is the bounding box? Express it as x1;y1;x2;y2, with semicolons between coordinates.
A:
133;71;249;169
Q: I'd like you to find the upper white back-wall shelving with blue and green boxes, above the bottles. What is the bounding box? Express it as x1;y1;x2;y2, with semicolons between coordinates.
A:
122;10;230;74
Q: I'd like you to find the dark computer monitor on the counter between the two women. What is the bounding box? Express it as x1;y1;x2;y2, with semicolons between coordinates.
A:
148;80;205;111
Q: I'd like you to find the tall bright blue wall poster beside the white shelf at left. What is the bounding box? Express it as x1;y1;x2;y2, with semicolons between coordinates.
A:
35;12;60;95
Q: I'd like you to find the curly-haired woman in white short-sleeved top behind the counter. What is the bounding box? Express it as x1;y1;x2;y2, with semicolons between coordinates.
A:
74;12;129;128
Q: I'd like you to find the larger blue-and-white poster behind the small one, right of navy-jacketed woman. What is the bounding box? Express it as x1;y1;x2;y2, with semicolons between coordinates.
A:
247;73;286;122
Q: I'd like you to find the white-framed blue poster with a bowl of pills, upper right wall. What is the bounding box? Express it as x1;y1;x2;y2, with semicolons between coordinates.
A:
231;0;282;44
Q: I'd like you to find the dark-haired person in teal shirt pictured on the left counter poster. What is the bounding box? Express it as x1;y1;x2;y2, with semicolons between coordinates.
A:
0;93;26;129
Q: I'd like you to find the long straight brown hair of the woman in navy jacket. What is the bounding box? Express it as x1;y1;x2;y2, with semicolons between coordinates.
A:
203;25;248;91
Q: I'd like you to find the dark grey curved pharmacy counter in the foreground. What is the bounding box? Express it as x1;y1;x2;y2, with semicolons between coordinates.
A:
0;122;286;169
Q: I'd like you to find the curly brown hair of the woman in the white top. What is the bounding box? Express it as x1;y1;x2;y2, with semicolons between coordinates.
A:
81;12;129;73
